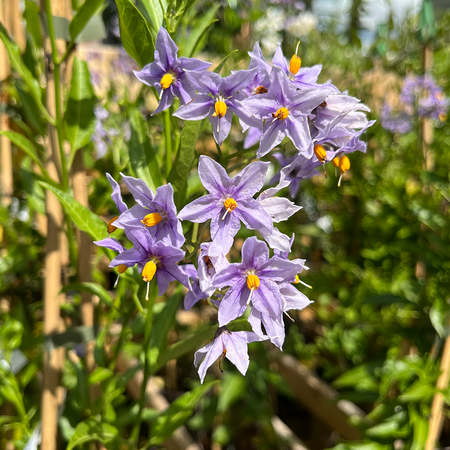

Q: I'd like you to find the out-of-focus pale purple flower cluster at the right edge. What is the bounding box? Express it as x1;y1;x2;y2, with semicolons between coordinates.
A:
381;74;450;133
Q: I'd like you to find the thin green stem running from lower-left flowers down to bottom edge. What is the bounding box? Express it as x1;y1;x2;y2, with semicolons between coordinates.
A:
131;280;157;448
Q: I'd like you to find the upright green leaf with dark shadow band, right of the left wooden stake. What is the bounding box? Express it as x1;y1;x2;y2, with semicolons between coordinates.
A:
64;58;96;156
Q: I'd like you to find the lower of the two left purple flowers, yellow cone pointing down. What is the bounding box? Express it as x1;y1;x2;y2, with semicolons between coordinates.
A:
109;228;190;298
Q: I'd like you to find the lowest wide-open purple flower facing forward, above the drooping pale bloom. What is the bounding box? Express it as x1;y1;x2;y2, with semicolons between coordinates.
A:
214;237;303;326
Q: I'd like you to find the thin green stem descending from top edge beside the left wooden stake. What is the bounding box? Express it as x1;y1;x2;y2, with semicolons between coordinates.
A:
45;0;69;191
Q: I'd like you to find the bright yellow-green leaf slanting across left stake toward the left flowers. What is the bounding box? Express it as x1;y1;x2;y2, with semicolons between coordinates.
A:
39;181;106;241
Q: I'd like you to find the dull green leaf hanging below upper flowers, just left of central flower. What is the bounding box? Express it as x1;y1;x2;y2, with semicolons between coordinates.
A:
169;120;202;205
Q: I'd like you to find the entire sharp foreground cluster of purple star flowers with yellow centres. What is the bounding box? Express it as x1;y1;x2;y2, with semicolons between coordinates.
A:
96;28;372;382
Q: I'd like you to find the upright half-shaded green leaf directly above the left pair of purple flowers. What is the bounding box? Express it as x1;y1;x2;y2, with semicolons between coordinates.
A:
129;109;163;191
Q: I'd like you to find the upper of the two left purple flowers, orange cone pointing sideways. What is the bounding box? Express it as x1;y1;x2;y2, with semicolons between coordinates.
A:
114;174;185;247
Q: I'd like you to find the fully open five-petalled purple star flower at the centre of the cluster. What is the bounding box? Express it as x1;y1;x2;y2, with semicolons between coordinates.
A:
178;155;273;254
